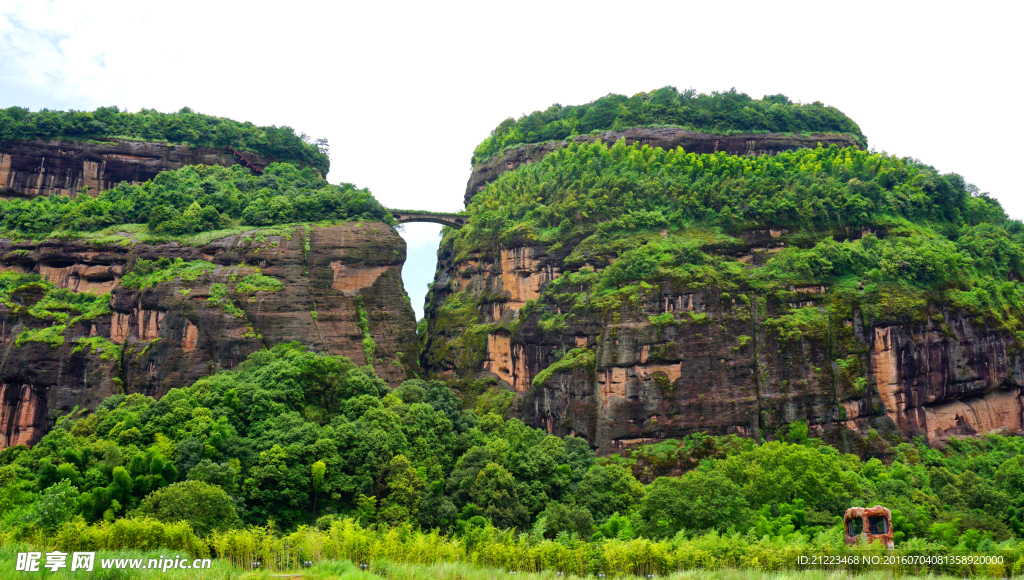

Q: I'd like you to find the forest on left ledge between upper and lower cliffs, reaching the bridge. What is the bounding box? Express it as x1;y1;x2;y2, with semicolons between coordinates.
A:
0;163;392;238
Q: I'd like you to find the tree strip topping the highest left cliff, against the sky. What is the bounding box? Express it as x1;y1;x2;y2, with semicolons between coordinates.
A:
0;107;331;175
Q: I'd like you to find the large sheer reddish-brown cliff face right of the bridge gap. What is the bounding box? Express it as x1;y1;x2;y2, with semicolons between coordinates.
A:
423;231;1024;454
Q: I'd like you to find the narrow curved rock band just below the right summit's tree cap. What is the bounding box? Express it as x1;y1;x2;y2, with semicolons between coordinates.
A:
465;127;860;205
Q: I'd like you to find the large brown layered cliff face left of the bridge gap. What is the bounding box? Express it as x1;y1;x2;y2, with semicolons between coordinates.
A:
0;222;418;448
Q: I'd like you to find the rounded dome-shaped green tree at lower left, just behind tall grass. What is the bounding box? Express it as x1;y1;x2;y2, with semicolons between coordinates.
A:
133;481;239;535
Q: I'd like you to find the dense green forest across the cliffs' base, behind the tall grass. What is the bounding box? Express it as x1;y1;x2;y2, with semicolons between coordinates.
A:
0;344;1024;565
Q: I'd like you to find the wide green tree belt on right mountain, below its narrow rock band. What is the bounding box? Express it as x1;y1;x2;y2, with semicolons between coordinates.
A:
458;140;999;250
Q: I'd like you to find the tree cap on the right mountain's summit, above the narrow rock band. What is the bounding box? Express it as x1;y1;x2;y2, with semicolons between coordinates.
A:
472;86;867;165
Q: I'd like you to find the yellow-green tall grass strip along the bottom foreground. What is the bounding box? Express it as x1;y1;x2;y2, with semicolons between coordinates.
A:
0;520;1024;578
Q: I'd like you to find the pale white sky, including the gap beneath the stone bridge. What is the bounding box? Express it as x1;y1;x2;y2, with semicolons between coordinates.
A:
0;0;1024;317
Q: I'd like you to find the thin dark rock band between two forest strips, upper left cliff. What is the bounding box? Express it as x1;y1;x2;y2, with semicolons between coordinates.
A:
0;140;272;197
